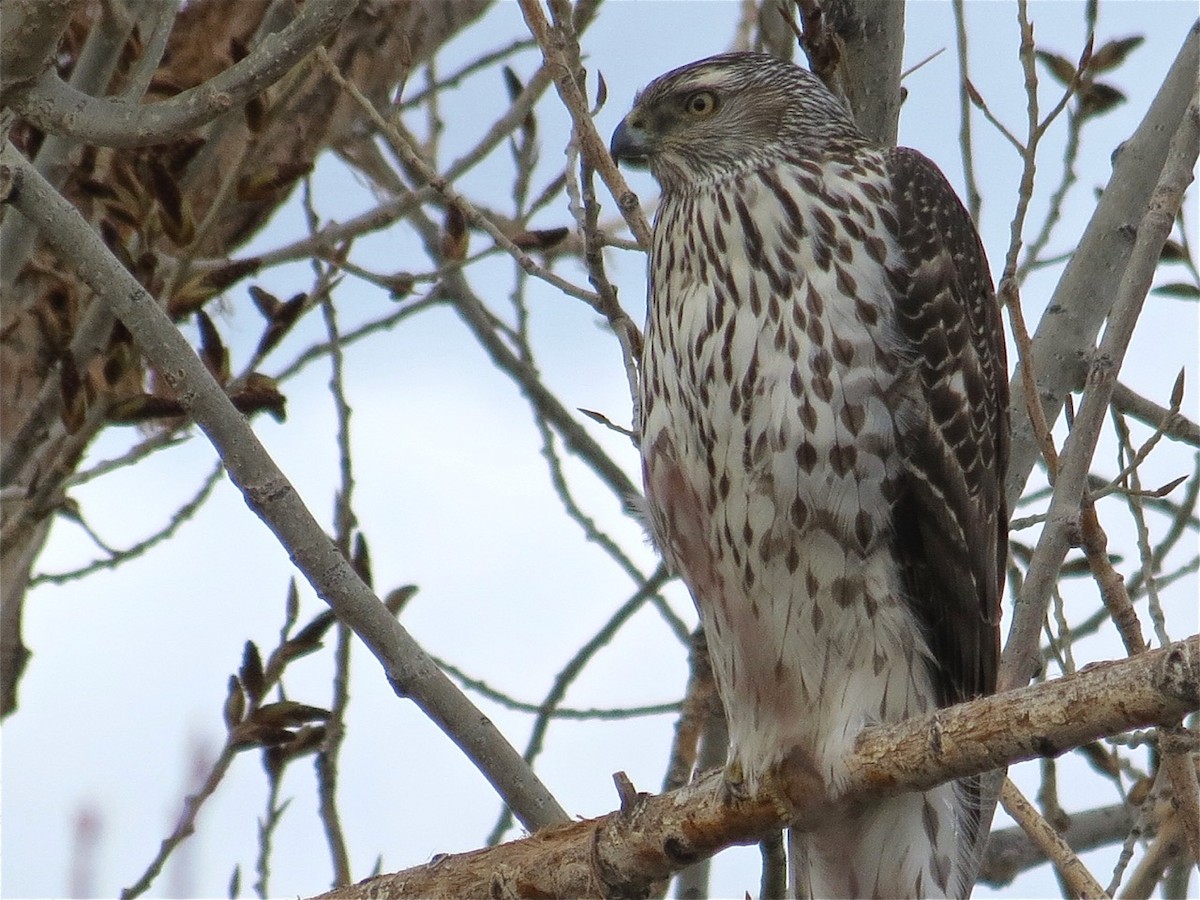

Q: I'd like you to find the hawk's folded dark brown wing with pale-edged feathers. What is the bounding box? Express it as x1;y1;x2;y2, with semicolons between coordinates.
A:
888;148;1008;706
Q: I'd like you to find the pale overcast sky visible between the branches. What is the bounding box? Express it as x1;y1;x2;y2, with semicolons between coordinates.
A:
0;0;1200;896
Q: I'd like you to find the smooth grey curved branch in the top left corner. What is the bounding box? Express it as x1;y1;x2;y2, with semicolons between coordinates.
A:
12;0;358;146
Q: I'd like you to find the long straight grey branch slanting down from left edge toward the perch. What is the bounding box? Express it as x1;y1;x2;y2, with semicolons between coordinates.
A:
0;144;566;830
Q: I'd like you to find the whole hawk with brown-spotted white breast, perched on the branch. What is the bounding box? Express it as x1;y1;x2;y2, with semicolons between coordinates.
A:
612;54;1008;896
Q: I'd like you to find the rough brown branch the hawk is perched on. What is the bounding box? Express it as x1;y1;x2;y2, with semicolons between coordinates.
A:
322;636;1200;898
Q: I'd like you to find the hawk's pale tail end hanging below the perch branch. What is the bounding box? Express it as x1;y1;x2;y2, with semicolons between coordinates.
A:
787;782;978;900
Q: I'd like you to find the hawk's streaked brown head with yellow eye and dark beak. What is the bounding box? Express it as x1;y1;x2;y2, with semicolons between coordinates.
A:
610;53;865;190
